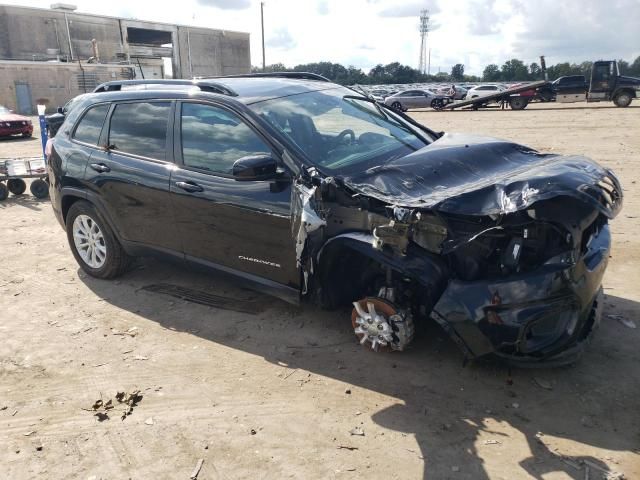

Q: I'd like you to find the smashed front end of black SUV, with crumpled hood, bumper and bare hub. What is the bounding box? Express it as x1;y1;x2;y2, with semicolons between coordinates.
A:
294;135;622;365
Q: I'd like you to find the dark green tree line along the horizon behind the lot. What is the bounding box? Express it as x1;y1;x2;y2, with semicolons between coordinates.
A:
252;56;640;85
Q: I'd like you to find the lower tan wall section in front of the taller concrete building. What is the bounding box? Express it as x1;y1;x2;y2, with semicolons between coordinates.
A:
0;61;133;115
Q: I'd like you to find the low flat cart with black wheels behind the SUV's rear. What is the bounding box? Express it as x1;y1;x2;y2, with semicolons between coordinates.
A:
0;157;49;201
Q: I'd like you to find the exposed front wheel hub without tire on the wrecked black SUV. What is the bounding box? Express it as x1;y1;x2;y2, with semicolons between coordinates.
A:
351;297;413;351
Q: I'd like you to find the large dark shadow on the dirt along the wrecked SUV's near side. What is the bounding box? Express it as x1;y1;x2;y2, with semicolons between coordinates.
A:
80;259;640;480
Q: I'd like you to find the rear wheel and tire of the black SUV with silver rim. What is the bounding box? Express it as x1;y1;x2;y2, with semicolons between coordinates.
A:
66;200;131;279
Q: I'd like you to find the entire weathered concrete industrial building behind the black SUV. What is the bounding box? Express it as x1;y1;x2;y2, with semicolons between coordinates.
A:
0;4;251;115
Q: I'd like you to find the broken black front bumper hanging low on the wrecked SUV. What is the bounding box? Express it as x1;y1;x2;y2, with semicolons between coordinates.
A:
431;225;611;366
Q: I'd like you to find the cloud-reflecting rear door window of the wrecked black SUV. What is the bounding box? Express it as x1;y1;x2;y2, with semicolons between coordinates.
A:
109;102;171;160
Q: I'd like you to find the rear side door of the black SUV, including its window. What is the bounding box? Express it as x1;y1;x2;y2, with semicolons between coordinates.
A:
85;100;181;256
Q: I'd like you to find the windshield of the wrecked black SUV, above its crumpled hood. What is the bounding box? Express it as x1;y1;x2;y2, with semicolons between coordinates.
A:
250;88;431;174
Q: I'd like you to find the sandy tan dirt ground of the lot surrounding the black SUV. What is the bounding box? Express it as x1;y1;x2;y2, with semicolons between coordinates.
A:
0;105;640;480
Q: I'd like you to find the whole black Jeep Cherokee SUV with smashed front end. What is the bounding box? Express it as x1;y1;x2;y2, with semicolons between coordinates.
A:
49;73;622;364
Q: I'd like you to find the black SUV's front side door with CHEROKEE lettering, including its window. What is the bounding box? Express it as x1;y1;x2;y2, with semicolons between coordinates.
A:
171;102;299;288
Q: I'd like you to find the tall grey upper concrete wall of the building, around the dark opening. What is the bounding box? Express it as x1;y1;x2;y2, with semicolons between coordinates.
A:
0;5;251;78
